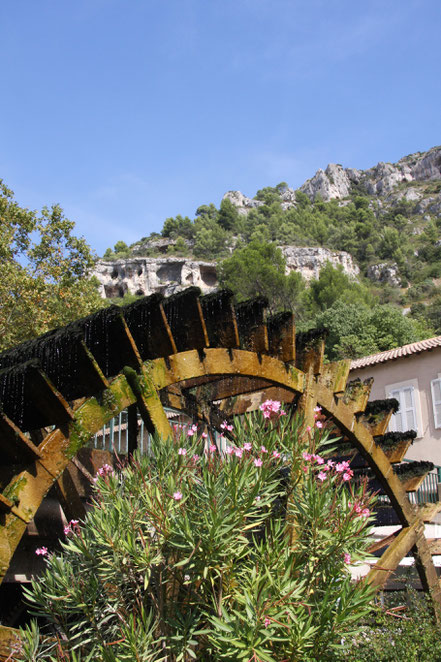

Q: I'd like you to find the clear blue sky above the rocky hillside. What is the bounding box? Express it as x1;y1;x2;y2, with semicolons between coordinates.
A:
0;0;441;254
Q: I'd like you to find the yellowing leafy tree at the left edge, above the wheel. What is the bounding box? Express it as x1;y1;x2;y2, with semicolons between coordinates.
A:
0;180;104;350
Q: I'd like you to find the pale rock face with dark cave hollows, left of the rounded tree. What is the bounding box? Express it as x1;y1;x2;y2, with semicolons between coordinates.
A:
94;257;217;298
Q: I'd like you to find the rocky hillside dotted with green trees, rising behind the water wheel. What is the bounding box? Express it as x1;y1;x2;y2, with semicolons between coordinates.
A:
97;147;441;354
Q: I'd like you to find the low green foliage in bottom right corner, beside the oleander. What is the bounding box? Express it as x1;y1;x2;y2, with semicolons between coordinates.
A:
336;589;441;662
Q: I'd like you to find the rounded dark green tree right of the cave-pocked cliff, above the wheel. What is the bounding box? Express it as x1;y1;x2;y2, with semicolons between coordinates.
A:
219;240;304;312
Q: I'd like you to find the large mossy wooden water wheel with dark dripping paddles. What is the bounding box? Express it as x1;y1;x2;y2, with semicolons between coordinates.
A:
0;288;441;654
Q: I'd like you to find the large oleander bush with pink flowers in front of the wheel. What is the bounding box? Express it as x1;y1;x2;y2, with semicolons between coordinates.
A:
18;412;372;662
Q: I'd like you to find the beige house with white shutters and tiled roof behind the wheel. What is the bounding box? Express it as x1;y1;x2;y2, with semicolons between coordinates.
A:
349;336;441;466
